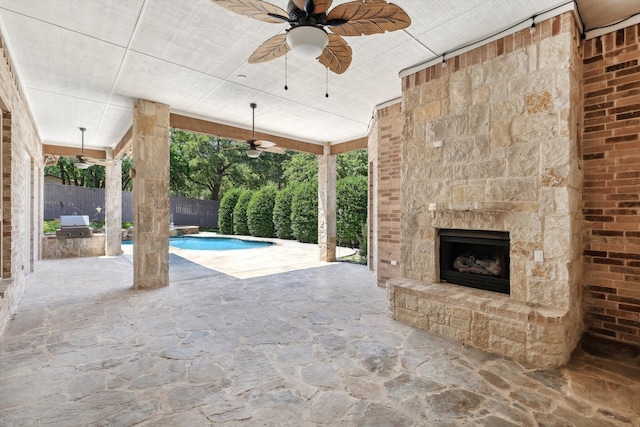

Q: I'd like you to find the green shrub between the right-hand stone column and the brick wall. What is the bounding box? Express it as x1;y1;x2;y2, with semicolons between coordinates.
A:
336;176;368;248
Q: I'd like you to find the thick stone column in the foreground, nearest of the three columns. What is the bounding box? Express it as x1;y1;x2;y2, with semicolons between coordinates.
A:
133;99;169;289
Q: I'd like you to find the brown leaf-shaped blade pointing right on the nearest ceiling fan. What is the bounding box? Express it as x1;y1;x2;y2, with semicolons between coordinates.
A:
327;0;411;36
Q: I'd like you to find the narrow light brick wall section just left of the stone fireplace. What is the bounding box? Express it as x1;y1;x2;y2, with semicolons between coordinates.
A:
370;103;402;286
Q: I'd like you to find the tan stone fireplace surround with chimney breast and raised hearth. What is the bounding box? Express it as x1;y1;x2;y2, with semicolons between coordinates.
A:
388;13;582;366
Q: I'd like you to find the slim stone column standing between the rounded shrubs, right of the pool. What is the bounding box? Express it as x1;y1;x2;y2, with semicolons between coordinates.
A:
318;142;336;262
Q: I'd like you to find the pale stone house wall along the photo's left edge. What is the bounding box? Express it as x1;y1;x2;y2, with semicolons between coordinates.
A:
0;37;43;333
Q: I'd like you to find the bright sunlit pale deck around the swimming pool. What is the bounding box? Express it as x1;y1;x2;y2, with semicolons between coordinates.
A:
122;232;354;279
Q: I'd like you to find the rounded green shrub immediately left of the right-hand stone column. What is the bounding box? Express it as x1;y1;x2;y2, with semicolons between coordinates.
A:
291;181;318;243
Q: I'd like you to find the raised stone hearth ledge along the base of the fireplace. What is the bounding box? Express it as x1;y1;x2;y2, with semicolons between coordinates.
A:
387;278;582;367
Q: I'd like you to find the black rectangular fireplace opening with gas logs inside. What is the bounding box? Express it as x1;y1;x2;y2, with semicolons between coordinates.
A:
438;229;510;294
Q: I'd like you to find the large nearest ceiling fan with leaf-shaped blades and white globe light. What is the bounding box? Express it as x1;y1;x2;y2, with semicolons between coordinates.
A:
211;0;411;74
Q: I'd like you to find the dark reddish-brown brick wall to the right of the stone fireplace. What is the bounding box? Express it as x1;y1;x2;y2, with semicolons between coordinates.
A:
582;25;640;344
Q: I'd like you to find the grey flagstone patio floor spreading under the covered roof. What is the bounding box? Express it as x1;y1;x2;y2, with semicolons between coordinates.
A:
0;239;640;427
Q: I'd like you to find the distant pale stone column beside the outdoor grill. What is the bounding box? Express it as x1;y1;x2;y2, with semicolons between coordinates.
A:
103;149;122;256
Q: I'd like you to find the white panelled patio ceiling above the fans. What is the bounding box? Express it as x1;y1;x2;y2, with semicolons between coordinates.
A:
0;0;640;149
